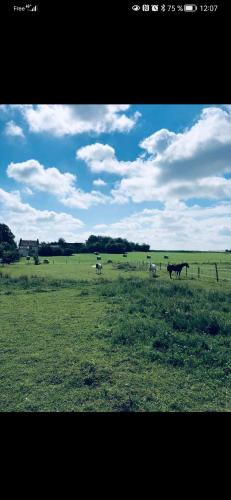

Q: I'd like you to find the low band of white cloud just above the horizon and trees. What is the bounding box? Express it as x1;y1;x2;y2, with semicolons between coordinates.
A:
0;188;231;250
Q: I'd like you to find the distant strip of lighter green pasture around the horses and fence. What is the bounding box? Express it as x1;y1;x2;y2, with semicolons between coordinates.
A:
0;252;231;288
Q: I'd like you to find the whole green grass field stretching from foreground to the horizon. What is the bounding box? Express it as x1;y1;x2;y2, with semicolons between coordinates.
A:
0;252;231;412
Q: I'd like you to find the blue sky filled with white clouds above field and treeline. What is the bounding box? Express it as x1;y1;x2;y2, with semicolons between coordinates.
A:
0;104;231;250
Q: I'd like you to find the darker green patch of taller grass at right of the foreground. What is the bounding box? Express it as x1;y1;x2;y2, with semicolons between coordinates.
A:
102;279;231;374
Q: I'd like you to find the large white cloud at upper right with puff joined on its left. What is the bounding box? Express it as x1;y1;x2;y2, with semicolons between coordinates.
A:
76;106;231;204
